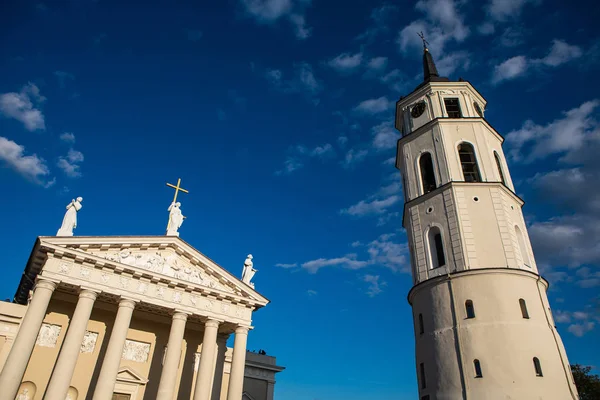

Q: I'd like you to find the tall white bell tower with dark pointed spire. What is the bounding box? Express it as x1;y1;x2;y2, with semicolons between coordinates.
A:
396;43;579;400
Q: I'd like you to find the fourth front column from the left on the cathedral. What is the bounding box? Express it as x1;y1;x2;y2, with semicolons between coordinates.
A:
156;311;188;400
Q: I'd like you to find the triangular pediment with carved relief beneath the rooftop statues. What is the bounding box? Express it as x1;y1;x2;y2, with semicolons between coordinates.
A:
39;236;269;306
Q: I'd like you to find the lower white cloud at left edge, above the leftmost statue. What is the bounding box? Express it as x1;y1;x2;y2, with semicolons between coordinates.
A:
0;136;52;186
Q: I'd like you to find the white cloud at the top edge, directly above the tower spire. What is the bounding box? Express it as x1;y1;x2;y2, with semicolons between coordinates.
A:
397;0;470;54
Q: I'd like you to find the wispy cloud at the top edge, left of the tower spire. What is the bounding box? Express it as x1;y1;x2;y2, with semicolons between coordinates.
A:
240;0;311;39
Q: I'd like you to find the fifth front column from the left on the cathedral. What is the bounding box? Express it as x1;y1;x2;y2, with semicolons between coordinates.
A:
194;319;219;400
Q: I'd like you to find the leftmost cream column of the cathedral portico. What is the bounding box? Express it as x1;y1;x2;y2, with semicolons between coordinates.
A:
0;278;56;400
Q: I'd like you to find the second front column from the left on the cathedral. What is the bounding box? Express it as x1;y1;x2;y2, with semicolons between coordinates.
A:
44;289;98;400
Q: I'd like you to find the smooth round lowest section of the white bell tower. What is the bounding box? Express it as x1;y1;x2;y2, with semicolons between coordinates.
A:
409;269;575;400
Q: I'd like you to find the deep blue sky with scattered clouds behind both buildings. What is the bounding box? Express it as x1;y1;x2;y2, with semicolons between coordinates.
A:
0;0;600;400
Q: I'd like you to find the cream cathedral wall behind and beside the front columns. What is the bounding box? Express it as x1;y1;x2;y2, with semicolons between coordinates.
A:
0;293;282;400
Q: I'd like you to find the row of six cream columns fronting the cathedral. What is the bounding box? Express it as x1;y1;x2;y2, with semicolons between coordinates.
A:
0;277;248;400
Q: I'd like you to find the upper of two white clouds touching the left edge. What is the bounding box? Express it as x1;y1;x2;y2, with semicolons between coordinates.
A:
0;83;46;131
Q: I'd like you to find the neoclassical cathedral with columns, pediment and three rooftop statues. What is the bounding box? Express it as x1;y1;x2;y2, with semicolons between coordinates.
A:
0;189;284;400
